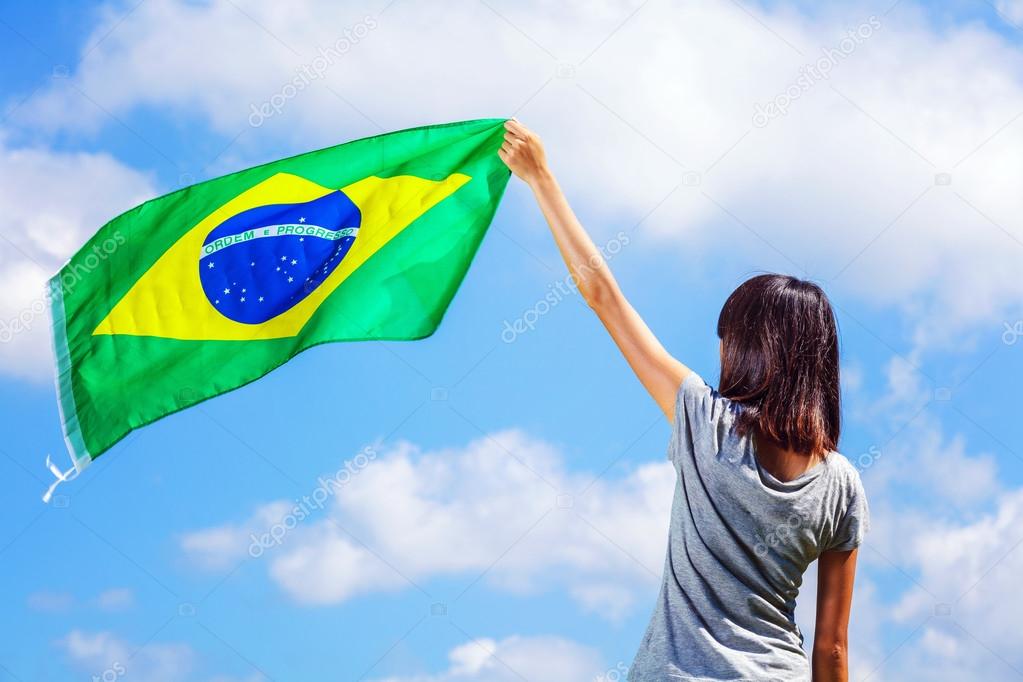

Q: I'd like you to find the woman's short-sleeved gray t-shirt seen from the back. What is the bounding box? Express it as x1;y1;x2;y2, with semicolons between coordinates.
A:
629;373;870;682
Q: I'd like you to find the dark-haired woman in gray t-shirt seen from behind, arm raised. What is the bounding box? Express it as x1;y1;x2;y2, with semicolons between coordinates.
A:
499;121;870;682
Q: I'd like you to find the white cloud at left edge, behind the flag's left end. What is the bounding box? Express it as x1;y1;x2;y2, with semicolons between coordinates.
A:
0;135;154;379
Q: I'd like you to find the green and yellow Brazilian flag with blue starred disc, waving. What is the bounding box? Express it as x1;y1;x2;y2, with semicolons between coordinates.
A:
49;120;509;480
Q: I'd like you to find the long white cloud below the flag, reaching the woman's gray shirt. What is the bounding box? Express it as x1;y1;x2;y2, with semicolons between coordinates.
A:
182;430;675;619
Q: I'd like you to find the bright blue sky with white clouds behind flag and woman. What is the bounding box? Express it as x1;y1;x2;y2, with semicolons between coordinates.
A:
0;0;1023;682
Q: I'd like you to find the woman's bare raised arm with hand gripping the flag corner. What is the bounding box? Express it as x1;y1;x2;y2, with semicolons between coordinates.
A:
498;120;691;421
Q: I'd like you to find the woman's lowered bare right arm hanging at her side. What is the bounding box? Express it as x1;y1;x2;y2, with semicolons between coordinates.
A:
813;549;857;682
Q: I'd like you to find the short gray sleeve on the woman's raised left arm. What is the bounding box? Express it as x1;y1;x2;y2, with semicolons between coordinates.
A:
668;372;729;471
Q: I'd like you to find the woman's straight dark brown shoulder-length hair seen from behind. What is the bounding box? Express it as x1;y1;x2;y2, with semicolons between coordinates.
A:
717;274;842;455
